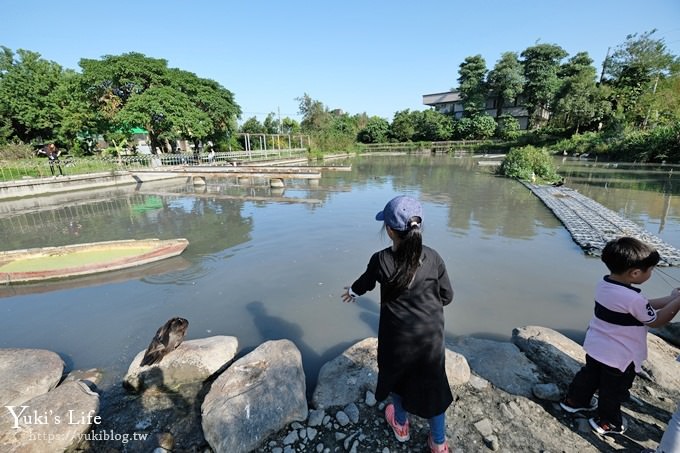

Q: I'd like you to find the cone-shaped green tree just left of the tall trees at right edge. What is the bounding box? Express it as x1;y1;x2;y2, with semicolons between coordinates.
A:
552;52;611;133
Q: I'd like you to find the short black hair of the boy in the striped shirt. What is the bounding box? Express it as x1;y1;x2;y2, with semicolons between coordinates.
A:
602;236;661;274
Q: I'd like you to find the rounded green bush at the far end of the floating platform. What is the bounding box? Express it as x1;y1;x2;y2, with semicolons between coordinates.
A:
498;145;557;182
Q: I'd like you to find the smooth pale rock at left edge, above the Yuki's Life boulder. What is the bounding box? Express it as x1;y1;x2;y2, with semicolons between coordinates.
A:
0;349;64;407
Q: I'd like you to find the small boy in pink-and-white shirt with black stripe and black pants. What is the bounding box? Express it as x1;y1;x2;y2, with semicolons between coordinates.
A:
560;237;680;434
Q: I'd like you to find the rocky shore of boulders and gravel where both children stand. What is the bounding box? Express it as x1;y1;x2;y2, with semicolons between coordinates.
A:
0;323;680;453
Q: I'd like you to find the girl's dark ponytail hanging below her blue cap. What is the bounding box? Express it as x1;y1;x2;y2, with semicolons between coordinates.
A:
388;216;423;295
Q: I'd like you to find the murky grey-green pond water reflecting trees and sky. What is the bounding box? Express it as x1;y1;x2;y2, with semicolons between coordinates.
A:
0;155;680;391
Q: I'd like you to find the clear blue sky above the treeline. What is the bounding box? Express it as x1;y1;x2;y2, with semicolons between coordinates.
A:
0;0;680;121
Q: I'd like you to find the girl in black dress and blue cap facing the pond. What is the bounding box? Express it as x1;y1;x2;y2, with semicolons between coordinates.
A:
342;196;453;453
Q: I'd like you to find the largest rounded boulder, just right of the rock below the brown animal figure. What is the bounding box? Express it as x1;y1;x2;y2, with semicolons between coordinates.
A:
201;340;307;453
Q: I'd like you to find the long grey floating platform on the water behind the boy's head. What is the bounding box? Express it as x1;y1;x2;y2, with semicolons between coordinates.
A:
524;183;680;266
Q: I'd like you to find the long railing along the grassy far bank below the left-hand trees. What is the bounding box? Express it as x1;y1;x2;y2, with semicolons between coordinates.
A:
0;148;307;181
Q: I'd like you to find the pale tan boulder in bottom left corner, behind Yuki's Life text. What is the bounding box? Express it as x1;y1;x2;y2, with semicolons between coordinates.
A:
0;381;101;453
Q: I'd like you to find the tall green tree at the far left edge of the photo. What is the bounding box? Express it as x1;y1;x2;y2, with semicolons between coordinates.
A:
0;46;64;142
